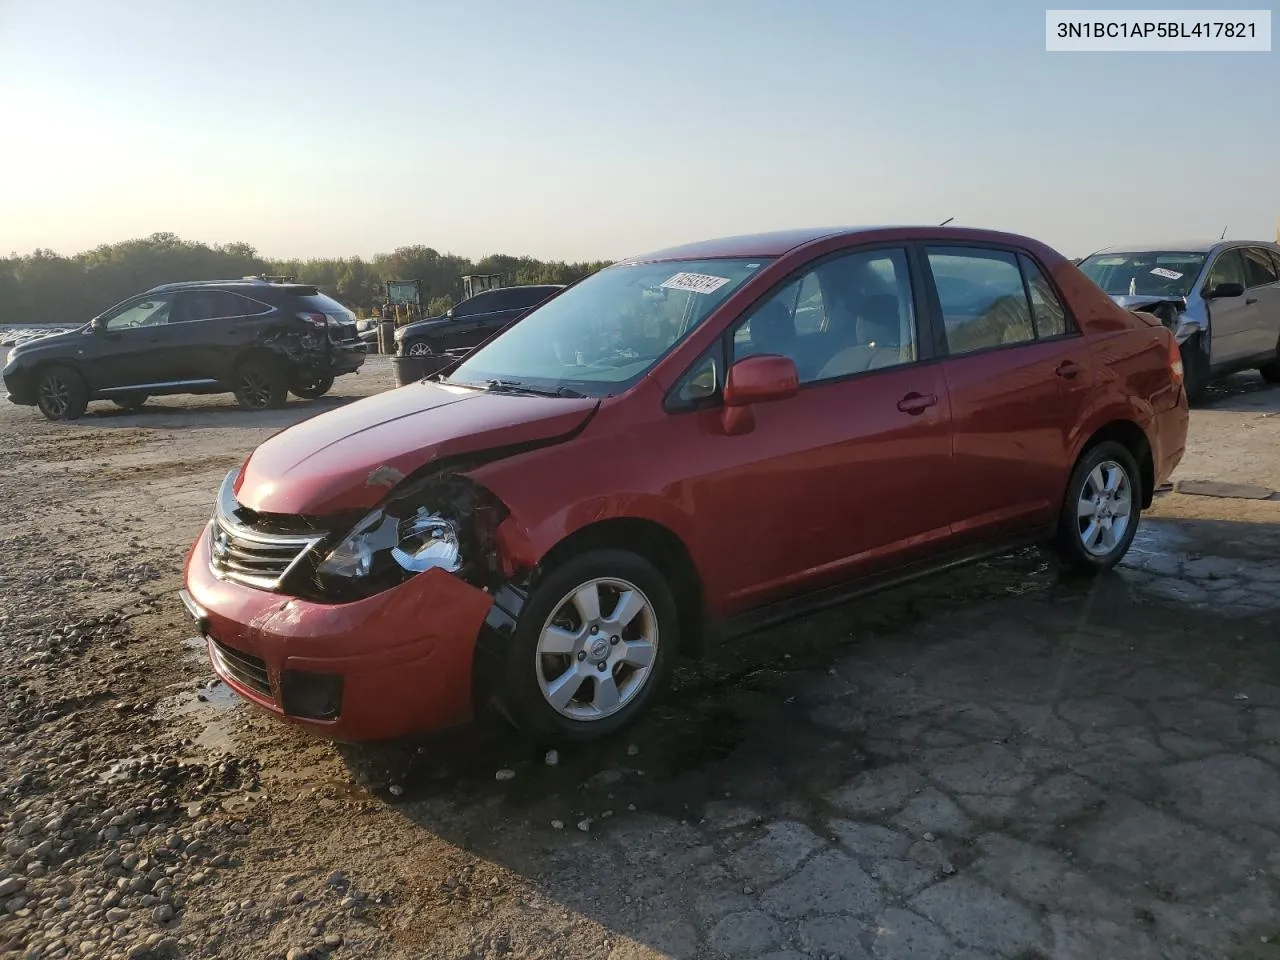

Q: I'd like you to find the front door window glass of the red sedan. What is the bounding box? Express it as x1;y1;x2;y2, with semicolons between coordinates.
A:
733;250;916;384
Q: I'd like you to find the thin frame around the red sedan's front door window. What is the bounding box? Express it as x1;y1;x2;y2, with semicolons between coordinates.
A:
662;239;943;415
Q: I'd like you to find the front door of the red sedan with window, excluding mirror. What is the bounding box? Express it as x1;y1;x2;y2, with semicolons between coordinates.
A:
663;241;951;614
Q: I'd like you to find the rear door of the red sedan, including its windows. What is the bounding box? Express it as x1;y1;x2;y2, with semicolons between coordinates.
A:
924;243;1093;543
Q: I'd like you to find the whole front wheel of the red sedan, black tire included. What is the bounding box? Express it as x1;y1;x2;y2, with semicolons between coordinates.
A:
497;549;680;742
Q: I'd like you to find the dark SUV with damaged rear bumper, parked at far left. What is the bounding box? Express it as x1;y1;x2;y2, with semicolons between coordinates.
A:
4;278;365;420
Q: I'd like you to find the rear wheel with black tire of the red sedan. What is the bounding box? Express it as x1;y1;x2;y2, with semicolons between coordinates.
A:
1053;440;1142;576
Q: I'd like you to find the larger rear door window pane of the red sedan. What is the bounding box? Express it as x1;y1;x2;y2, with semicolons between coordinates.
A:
928;247;1036;355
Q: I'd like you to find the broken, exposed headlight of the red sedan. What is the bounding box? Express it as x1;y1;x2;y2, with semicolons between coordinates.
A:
315;476;506;596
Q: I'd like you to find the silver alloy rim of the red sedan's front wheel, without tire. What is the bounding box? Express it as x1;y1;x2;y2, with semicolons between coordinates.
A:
535;577;659;721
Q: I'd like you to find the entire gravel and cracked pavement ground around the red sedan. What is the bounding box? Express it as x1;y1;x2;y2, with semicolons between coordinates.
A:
0;358;1280;960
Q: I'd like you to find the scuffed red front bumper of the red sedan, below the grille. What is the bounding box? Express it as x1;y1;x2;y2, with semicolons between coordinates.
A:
180;526;493;741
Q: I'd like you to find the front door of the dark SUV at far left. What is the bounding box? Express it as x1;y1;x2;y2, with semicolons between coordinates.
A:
86;294;178;392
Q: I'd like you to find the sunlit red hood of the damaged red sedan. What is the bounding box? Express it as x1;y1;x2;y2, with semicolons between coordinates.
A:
236;383;599;516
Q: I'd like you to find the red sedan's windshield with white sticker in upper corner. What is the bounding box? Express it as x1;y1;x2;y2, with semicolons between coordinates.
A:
449;257;768;397
